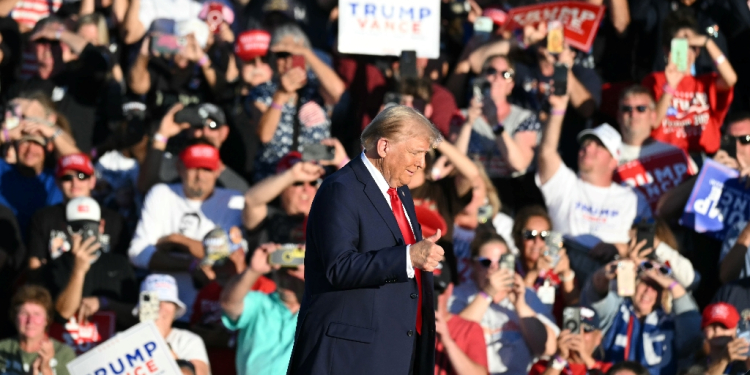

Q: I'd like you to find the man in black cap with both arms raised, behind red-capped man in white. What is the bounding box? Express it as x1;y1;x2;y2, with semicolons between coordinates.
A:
138;103;250;194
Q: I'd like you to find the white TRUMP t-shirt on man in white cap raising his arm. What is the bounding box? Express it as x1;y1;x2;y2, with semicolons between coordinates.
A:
535;164;651;248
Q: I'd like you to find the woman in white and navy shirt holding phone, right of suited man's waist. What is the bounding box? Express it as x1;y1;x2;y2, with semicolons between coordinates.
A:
448;232;560;374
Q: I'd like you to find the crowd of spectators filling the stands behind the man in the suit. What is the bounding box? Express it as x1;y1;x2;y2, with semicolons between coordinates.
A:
0;0;750;375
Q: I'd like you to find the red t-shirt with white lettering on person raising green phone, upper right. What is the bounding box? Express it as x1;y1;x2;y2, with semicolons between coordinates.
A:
642;72;733;154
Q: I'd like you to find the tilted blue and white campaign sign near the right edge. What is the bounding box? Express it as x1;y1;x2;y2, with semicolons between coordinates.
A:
680;159;750;240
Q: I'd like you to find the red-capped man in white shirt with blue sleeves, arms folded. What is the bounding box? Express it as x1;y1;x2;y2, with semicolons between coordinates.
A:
128;140;245;321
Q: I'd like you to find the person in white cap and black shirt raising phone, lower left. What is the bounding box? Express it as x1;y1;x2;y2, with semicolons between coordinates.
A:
44;197;138;354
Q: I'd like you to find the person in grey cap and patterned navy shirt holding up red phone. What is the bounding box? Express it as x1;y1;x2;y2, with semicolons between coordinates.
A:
249;23;345;182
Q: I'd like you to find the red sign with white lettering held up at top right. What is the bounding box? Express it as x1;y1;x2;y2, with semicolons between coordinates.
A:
505;1;604;52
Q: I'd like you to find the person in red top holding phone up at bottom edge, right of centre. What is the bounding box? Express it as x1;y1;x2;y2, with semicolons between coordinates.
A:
529;306;612;375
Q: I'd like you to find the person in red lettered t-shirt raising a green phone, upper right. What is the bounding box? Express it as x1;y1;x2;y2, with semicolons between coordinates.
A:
641;10;737;154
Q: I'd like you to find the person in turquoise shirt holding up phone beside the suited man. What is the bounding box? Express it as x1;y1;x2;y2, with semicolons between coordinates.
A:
221;244;305;375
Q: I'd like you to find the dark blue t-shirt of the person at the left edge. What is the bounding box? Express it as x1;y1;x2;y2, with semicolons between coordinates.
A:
0;159;63;237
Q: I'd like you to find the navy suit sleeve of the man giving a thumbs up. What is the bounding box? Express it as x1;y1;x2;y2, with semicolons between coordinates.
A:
308;182;409;289
